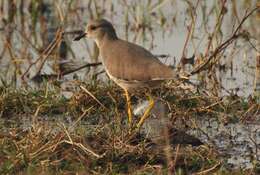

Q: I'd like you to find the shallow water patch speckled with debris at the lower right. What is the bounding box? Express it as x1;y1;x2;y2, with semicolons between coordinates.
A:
188;115;260;169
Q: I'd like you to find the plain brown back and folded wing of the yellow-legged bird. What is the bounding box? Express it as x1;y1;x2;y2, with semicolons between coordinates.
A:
100;39;174;82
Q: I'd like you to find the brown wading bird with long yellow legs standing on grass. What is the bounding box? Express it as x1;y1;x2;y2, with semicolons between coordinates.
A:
74;19;178;128
